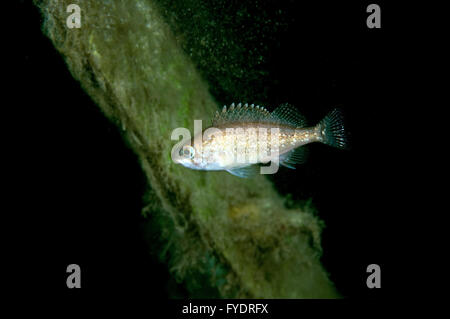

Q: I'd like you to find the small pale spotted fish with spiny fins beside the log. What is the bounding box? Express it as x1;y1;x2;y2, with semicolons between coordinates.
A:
174;103;347;177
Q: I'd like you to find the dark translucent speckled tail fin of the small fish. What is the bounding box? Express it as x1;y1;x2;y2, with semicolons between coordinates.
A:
318;109;348;149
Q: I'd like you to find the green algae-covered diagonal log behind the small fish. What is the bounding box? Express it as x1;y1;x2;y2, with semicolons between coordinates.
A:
35;0;338;298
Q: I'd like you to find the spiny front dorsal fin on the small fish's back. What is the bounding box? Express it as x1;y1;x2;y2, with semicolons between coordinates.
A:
212;103;270;126
